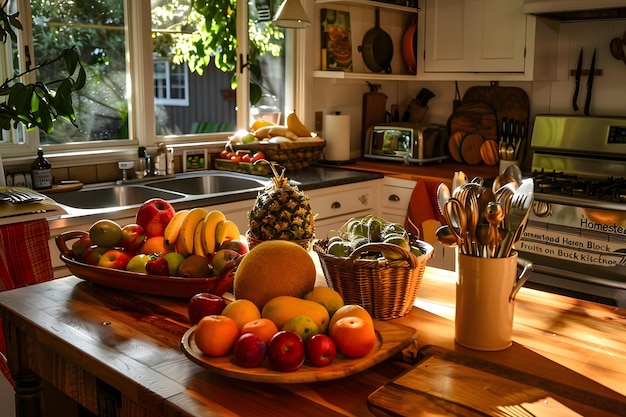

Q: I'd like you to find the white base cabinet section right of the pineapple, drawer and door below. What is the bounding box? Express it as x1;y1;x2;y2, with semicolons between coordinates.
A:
304;180;380;239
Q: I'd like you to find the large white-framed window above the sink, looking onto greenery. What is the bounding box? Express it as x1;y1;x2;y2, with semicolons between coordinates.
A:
0;0;285;156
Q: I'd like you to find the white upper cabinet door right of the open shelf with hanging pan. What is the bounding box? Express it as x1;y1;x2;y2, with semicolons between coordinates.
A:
424;0;526;72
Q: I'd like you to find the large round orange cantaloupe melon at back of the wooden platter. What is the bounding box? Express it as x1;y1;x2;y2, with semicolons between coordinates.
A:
233;240;316;310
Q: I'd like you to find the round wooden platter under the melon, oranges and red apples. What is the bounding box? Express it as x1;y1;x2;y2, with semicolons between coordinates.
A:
181;320;417;384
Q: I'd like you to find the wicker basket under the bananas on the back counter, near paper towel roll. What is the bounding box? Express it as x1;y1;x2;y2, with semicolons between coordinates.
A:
229;138;326;171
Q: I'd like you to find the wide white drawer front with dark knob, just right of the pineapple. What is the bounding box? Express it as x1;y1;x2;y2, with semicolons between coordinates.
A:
310;187;376;220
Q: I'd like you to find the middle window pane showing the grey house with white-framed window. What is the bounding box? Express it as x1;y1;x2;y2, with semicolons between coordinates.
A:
152;0;237;135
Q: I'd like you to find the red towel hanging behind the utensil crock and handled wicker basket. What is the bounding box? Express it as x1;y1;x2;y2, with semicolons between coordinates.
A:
404;178;445;245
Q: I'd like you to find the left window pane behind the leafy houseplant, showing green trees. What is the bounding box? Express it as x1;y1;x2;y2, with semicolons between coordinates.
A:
30;0;129;144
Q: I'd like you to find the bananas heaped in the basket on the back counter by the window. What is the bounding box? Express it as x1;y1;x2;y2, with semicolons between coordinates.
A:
229;112;322;144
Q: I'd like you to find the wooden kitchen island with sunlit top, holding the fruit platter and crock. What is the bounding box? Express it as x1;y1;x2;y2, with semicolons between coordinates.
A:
0;268;626;417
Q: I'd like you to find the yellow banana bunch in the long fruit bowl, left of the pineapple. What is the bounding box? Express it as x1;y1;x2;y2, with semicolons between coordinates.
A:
164;207;240;257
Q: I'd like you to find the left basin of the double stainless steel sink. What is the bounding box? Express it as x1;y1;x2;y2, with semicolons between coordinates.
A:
51;185;185;209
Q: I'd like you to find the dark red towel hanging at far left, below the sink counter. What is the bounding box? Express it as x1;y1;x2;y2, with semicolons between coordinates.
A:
0;219;54;382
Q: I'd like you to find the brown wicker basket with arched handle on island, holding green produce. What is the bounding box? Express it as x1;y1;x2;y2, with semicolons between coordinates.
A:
313;240;433;320
